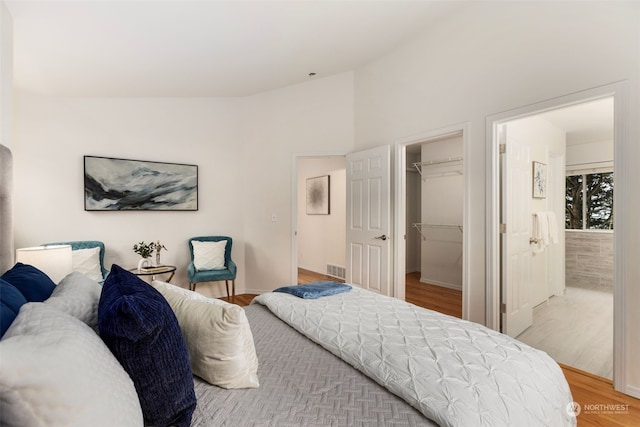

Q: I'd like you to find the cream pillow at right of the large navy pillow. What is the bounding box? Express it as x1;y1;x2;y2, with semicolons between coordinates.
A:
152;280;259;389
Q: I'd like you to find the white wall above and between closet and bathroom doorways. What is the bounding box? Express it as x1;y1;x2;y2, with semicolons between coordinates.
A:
355;2;640;396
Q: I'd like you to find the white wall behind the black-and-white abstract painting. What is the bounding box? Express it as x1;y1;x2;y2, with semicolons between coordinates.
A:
14;93;245;296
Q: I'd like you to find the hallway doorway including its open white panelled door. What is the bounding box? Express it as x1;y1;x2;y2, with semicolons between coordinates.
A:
291;146;396;296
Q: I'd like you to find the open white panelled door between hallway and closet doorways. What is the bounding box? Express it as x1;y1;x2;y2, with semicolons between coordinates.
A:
346;146;393;296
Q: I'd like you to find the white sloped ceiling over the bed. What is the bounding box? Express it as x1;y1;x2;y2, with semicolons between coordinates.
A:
5;0;466;97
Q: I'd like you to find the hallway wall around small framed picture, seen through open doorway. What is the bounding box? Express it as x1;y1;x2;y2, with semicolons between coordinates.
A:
297;156;347;274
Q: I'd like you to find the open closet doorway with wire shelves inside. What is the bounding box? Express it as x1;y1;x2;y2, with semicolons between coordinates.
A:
396;127;466;318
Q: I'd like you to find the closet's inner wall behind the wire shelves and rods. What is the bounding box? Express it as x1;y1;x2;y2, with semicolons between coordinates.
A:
420;136;464;290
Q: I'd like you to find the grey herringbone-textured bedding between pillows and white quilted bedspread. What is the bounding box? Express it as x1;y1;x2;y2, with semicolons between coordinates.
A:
192;304;437;427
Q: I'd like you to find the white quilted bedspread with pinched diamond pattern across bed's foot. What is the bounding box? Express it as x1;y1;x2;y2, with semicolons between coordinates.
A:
254;287;576;427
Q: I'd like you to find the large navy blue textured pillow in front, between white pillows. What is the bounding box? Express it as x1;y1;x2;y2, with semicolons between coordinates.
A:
98;264;196;427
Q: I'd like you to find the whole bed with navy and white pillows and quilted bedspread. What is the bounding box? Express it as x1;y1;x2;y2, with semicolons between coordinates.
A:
0;144;576;427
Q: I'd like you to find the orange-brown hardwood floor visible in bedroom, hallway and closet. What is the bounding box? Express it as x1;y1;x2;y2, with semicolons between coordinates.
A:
228;269;640;427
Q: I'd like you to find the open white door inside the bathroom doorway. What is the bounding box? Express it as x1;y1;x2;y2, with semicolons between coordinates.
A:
500;125;533;337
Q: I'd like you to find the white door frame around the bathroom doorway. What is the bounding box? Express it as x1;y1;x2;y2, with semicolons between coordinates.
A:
487;83;626;390
